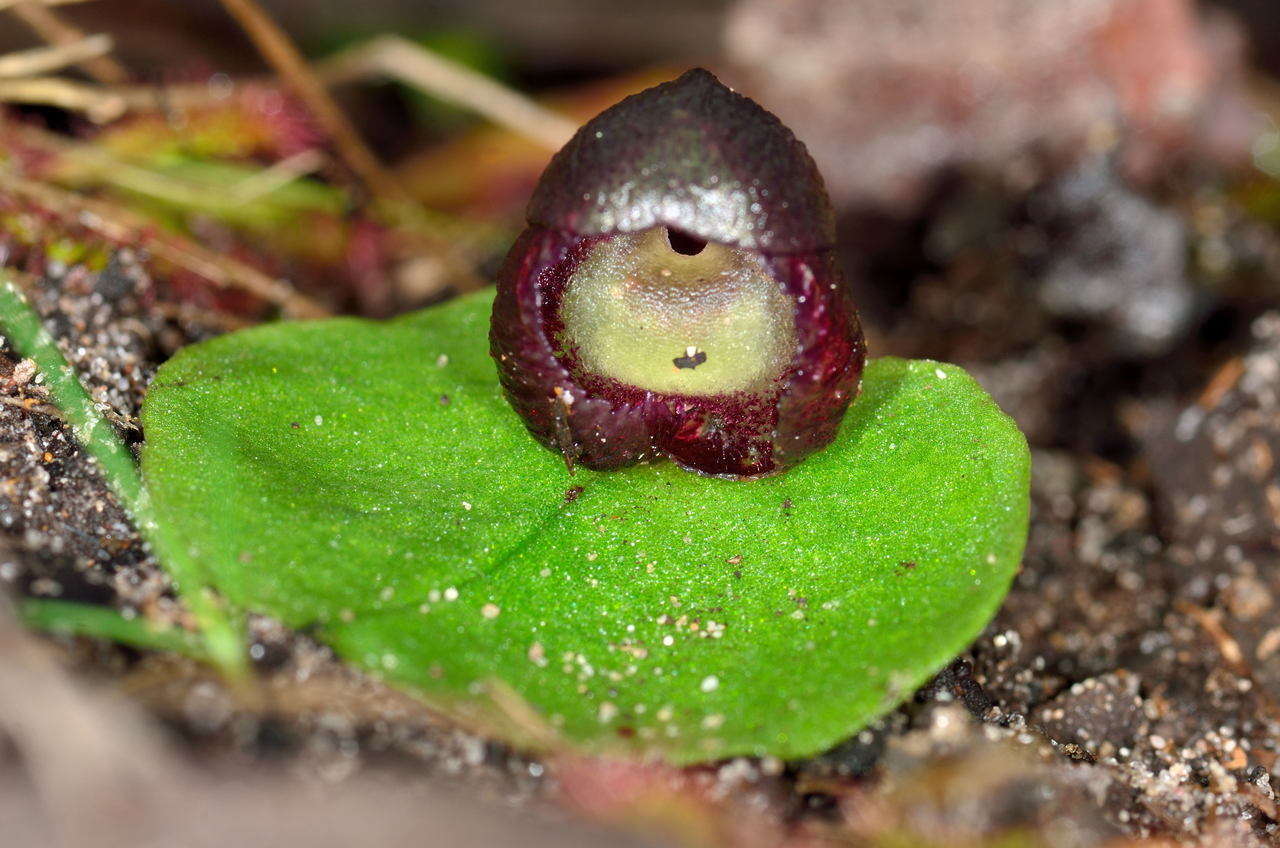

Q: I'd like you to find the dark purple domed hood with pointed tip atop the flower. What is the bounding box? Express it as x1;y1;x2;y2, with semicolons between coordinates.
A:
529;68;836;254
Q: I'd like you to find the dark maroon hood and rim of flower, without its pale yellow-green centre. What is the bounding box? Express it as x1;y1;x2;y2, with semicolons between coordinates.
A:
490;70;865;478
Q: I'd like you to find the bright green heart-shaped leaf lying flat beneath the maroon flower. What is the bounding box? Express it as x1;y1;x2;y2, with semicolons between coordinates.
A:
143;295;1029;762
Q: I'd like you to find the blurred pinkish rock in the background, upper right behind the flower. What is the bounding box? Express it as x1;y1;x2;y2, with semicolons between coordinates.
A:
726;0;1252;213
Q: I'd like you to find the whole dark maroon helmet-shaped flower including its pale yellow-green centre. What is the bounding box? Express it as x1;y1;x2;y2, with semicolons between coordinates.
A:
490;70;865;477
